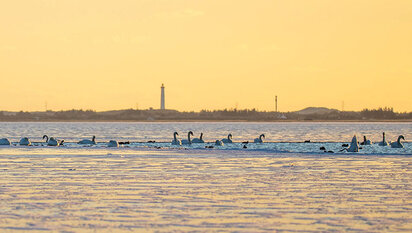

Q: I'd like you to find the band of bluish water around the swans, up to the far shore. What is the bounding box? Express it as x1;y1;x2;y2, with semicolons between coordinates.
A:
0;122;412;155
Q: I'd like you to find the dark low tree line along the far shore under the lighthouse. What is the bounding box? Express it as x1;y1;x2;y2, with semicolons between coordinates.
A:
0;107;412;121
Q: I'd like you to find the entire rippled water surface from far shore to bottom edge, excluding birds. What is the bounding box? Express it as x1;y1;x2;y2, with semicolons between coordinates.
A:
0;122;412;232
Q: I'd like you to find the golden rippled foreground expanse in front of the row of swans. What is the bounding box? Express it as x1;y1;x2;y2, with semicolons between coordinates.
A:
0;150;412;232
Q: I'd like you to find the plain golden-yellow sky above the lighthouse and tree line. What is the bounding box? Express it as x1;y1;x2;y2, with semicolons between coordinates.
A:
0;0;412;111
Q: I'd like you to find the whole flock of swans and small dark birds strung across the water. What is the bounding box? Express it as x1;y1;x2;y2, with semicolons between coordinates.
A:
0;131;405;153
